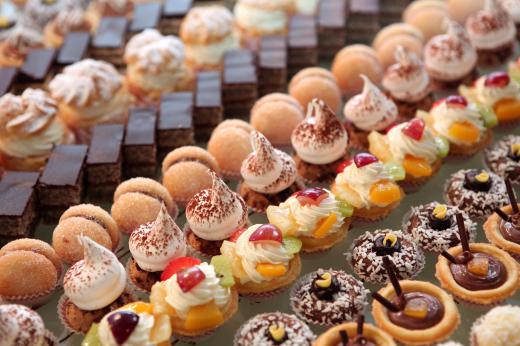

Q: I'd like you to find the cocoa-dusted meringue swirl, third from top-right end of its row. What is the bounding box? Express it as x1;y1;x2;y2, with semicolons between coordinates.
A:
383;45;431;102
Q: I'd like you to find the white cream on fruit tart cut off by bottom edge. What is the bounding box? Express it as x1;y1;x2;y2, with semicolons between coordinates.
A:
98;310;156;346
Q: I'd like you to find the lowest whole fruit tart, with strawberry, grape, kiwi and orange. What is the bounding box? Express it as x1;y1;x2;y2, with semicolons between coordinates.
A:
150;256;238;338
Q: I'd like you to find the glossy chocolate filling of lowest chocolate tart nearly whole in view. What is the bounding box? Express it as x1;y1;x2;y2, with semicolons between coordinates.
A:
388;292;444;330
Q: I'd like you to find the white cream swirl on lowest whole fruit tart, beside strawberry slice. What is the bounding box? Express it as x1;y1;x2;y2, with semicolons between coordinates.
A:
164;263;231;319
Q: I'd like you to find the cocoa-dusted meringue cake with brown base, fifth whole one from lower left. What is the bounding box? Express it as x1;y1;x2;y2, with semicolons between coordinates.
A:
291;99;348;182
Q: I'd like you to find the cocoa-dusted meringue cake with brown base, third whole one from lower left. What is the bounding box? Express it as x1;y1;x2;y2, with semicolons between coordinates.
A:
184;171;248;257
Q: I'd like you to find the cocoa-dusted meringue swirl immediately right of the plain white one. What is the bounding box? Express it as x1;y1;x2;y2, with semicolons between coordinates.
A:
128;203;186;272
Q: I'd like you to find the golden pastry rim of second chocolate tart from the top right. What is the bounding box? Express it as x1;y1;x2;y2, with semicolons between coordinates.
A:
435;243;520;305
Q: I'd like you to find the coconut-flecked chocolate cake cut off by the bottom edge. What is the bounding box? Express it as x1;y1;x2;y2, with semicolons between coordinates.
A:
233;312;316;346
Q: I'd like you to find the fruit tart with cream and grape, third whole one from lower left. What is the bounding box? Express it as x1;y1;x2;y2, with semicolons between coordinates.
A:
266;187;352;252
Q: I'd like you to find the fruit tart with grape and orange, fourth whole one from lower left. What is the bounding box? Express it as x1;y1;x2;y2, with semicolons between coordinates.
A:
331;153;405;221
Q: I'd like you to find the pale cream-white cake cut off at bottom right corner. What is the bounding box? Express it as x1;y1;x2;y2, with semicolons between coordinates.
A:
470;305;520;346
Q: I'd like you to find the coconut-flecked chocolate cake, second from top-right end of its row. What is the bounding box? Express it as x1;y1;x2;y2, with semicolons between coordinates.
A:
444;169;508;219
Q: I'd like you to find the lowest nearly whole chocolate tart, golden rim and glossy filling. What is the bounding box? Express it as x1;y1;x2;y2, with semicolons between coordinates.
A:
372;280;460;345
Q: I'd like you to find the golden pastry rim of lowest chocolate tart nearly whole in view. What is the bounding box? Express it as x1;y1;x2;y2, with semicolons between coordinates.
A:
372;280;460;345
